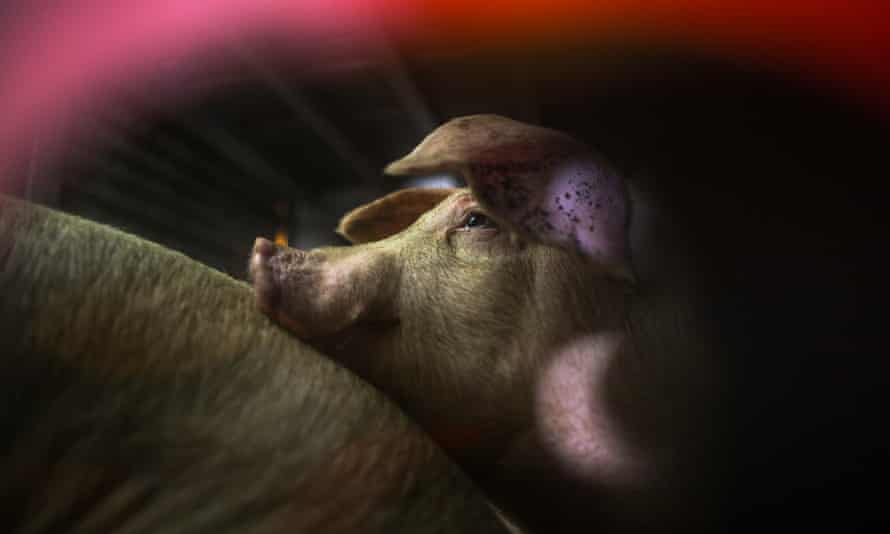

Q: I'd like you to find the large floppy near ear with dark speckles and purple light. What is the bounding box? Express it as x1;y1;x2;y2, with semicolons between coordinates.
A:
386;115;633;280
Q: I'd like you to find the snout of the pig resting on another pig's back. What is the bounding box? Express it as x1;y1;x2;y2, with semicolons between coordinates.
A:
248;238;393;340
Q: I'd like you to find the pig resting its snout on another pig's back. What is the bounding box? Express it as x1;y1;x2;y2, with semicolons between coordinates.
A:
250;115;719;532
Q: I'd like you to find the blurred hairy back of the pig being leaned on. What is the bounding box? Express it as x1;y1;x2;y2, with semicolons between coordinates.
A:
0;197;506;533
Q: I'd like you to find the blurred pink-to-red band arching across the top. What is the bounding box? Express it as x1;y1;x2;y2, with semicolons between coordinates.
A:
0;0;890;185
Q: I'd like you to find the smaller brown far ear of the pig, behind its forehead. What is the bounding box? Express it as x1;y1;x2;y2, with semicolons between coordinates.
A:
337;187;457;244
